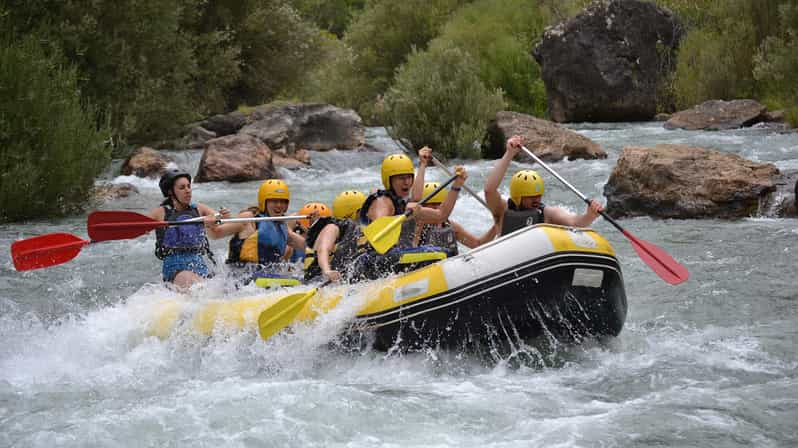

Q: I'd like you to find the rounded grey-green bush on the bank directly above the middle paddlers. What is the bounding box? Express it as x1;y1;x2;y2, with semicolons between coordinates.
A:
385;42;504;157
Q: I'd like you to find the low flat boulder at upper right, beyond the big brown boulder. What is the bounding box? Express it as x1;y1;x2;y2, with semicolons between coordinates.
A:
663;100;769;131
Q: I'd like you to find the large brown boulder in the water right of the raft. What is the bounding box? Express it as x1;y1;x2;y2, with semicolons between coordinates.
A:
604;145;779;219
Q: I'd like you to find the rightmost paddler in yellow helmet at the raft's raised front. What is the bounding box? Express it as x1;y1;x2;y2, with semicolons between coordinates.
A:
485;135;604;235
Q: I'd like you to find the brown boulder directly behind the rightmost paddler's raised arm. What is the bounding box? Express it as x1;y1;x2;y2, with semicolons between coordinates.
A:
486;111;607;162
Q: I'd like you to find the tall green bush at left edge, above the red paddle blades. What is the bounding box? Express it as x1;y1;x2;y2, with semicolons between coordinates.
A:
0;28;110;221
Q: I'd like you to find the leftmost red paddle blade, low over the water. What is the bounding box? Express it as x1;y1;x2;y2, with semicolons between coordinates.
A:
11;233;89;271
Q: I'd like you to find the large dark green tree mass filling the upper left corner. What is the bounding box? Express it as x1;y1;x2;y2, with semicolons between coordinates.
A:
0;0;318;141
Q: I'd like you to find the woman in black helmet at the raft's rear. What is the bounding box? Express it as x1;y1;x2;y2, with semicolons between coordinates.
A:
148;169;236;289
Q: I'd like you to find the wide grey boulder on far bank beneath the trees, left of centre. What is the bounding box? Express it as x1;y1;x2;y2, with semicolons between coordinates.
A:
239;104;366;151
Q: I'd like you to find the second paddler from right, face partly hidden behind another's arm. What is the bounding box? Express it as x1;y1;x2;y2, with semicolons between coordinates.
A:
412;146;499;257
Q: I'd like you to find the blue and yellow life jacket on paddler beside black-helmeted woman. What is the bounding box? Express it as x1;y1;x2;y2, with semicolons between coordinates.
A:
226;214;288;265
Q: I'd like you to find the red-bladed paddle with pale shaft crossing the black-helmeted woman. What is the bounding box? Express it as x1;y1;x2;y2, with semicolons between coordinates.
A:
88;211;308;242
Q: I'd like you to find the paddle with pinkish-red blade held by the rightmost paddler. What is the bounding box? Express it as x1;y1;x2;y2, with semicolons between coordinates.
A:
521;146;690;285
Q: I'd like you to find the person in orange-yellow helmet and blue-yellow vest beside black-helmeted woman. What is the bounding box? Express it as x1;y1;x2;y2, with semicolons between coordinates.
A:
226;179;305;283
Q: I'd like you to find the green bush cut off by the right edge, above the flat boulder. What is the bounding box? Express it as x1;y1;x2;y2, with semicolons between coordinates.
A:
754;4;798;126
